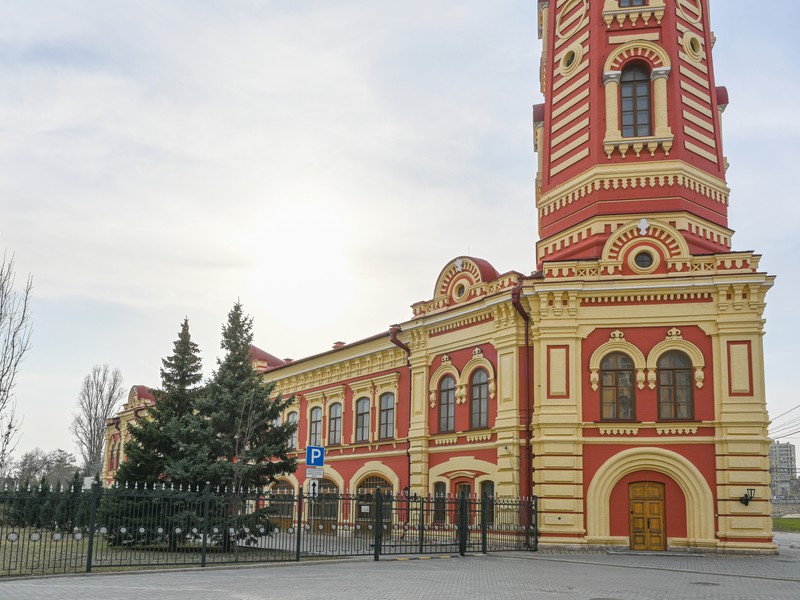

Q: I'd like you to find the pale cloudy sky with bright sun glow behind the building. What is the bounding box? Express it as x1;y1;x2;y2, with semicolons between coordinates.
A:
0;0;800;458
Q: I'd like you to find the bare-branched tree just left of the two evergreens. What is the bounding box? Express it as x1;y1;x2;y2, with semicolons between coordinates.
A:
70;365;124;476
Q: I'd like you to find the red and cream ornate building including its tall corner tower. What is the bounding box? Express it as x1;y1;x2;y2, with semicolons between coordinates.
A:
100;0;775;552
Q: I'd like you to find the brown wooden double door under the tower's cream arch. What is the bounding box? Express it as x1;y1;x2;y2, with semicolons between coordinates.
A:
628;481;667;552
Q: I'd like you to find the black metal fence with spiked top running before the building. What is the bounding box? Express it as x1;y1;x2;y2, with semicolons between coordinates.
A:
0;485;538;575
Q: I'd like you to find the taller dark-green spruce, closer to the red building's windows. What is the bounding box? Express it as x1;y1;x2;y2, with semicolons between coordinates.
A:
198;302;297;489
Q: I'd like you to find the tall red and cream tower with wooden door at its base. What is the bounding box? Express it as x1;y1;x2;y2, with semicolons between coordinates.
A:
523;0;774;551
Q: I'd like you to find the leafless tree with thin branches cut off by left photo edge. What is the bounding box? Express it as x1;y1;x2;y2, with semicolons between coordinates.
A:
0;252;33;472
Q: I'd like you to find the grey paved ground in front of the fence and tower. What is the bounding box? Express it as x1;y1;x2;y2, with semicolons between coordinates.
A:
0;535;800;600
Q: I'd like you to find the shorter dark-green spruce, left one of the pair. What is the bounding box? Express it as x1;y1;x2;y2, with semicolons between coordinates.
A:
116;319;205;485
